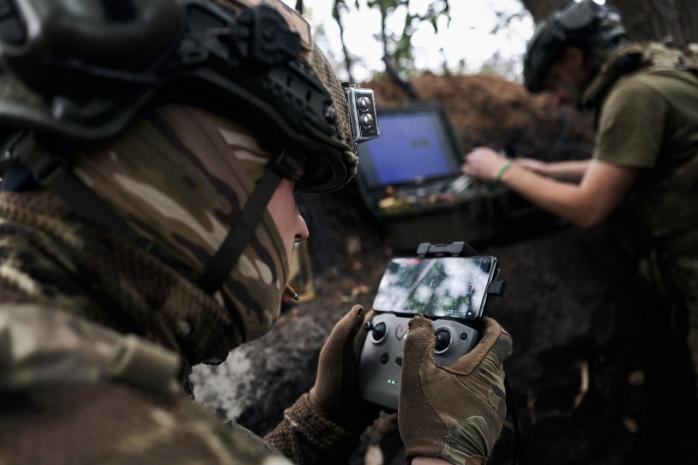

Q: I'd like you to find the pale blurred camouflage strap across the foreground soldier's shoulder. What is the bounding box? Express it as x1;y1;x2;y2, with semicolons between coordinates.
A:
0;304;179;394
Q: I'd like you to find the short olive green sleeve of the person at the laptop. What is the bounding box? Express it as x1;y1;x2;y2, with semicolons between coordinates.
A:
594;78;667;168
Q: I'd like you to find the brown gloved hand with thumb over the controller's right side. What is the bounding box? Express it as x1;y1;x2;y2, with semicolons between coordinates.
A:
398;316;512;465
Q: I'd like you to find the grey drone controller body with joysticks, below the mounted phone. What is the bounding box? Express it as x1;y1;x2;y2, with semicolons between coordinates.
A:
359;313;480;410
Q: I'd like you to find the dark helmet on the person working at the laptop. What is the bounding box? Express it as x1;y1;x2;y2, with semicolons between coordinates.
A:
524;0;625;92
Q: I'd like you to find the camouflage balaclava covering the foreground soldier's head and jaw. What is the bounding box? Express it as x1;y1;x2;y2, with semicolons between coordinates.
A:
75;106;288;344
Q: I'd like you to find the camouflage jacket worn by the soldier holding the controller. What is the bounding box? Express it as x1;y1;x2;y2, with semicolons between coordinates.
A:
0;193;355;465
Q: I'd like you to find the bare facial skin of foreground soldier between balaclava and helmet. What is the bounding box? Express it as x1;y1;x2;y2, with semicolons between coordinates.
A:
267;179;309;263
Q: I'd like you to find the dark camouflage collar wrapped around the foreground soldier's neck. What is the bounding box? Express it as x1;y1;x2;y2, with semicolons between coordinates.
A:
0;192;242;367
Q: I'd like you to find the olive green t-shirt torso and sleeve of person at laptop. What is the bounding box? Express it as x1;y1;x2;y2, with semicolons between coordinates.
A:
594;67;698;245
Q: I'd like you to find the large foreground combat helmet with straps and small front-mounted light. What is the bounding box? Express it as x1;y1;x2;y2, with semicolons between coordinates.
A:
0;0;378;320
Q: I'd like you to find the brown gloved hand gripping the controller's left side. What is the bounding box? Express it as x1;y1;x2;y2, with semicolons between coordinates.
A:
309;305;380;433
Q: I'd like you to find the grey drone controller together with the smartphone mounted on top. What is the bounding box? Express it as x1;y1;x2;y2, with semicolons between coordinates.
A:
359;242;504;410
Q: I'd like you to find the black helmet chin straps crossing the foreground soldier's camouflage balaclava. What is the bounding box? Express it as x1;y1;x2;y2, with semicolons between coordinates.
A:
6;125;302;295
